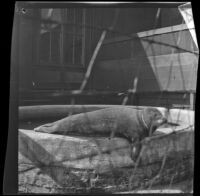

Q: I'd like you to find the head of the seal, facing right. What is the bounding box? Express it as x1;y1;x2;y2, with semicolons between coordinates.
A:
142;107;167;136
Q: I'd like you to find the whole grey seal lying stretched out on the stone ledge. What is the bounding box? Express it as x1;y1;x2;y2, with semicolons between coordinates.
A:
34;106;166;142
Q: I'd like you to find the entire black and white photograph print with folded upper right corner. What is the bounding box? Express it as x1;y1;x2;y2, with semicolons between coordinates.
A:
11;1;199;194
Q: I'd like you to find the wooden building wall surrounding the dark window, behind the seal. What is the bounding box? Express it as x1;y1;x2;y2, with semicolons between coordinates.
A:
19;8;198;108
